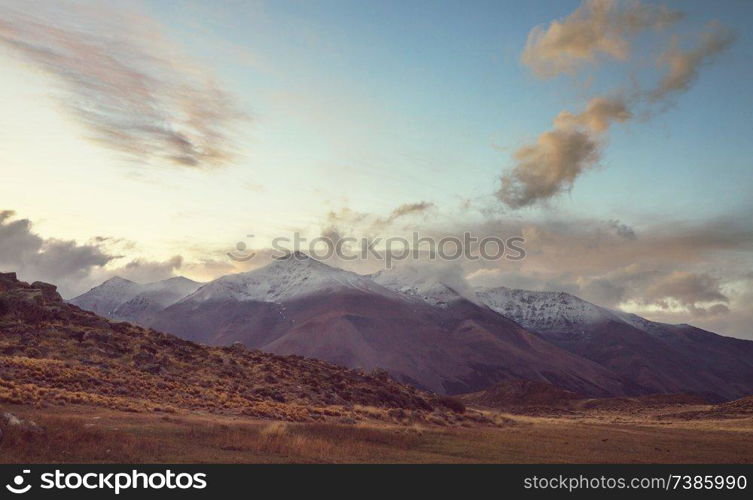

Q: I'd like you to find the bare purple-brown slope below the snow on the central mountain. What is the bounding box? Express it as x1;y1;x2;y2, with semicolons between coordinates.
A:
153;290;625;396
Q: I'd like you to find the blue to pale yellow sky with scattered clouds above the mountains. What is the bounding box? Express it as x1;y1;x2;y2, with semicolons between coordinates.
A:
0;0;753;338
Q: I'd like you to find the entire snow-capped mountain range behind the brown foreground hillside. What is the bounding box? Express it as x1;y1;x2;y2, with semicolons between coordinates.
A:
70;253;753;400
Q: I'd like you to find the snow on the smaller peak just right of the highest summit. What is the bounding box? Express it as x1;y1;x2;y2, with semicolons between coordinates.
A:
371;266;478;308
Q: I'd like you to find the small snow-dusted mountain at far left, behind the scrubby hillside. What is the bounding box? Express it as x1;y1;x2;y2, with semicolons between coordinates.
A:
68;276;201;325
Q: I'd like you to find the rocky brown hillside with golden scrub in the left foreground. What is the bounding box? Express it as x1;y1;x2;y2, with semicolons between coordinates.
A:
0;273;478;420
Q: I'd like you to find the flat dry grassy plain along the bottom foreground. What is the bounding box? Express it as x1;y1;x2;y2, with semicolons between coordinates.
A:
0;405;753;463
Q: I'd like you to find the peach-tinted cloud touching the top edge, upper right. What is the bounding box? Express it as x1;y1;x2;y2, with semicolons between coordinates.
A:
521;0;682;78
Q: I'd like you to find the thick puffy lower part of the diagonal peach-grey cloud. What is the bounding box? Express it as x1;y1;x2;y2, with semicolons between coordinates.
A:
497;97;632;208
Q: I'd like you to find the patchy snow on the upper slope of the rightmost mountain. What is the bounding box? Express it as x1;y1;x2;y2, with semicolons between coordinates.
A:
477;287;625;333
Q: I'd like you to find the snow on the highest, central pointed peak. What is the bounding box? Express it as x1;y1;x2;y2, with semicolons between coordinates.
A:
181;252;397;303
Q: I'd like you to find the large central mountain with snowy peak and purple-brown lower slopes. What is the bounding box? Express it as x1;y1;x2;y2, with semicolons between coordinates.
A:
145;254;623;395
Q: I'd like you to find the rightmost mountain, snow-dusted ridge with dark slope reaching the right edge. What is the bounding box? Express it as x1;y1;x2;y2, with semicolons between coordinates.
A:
478;287;753;399
